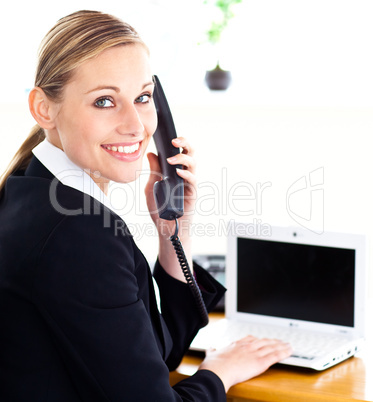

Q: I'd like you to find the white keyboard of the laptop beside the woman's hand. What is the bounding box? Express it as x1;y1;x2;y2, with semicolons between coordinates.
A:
196;320;346;360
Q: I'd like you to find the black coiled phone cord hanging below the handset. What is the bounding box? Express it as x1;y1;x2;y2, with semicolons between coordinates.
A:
170;218;209;327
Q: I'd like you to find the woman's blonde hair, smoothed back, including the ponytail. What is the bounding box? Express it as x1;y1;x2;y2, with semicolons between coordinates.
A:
0;10;146;195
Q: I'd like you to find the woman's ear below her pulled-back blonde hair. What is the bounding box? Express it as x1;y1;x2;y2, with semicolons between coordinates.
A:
28;87;56;130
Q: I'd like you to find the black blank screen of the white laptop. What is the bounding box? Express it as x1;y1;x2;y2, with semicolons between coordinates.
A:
237;237;355;327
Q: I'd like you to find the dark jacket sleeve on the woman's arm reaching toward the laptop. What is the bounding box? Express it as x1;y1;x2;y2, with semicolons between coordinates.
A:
33;215;225;402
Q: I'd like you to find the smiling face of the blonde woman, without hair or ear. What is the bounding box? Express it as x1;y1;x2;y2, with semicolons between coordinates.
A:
48;44;157;188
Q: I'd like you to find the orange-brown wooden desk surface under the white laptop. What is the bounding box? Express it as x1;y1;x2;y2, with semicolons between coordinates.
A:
170;316;373;402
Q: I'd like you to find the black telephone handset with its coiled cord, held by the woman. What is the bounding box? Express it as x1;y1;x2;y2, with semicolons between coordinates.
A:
153;75;209;326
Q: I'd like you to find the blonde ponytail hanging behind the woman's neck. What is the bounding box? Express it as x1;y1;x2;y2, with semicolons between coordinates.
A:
0;124;45;195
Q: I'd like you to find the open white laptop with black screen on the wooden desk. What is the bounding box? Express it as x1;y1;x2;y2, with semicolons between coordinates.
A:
191;223;367;370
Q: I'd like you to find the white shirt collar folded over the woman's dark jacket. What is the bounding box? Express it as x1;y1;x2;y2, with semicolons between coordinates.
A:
32;140;118;218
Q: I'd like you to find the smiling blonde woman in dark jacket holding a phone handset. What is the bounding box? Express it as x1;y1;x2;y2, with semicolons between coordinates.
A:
0;11;290;402
